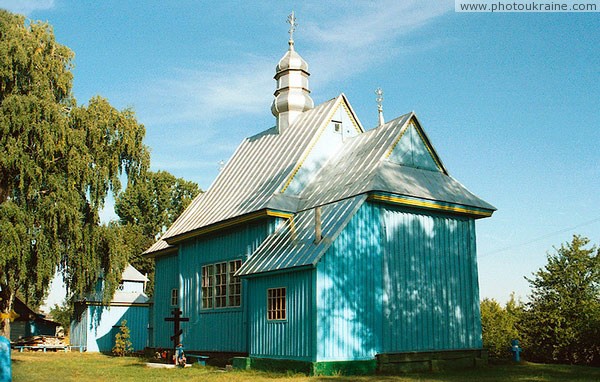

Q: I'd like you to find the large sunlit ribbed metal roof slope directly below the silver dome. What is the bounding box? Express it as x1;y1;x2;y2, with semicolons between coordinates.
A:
162;95;345;241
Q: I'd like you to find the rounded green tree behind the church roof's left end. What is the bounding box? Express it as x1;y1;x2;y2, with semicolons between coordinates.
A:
115;171;202;294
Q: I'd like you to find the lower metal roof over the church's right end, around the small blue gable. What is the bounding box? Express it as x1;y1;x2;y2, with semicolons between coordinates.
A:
300;113;495;210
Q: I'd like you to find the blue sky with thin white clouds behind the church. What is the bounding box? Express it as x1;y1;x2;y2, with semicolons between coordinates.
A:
0;0;600;302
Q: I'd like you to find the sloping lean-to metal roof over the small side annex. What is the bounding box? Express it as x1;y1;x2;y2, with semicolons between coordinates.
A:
236;195;366;276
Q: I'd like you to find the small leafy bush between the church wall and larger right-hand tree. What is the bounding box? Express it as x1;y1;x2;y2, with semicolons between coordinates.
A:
481;294;523;360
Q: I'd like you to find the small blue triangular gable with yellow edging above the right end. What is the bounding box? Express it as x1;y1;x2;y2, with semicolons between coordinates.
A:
388;119;445;172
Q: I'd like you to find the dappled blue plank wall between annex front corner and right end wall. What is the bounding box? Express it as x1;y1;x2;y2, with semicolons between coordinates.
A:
316;203;383;361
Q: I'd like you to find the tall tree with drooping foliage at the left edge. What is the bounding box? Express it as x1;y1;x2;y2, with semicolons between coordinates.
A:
0;10;149;336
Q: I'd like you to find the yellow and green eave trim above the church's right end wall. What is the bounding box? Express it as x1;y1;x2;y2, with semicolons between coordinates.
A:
367;191;495;219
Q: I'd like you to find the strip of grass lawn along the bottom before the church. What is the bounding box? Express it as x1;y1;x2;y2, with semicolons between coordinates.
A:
12;352;600;382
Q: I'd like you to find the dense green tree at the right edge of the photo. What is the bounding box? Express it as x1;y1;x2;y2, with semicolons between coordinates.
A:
521;235;600;365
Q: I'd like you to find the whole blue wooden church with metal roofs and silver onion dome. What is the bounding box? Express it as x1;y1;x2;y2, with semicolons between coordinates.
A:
146;17;495;373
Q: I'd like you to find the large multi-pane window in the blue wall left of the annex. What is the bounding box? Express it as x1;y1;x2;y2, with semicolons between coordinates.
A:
202;260;242;309
